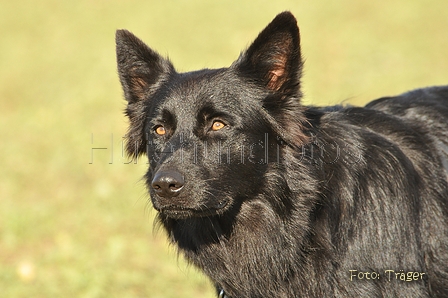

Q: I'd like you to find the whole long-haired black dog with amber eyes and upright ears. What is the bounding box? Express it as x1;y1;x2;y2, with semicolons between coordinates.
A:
116;12;448;297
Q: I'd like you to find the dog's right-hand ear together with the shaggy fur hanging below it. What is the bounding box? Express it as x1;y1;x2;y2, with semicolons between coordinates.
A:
232;12;309;147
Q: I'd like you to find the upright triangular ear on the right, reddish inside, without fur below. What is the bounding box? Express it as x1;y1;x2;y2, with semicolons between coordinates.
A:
234;12;302;93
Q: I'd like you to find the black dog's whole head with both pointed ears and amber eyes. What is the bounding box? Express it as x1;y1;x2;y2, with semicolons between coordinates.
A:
116;12;306;218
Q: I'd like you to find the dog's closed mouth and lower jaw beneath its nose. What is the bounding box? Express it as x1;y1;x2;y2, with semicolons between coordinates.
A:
154;199;229;219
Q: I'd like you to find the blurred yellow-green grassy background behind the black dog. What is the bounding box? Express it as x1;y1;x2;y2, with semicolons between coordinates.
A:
0;0;448;298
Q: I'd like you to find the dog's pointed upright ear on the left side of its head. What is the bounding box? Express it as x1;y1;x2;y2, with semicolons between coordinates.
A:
115;30;174;104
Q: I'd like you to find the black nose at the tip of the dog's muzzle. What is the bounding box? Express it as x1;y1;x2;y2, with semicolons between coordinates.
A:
151;171;184;197
